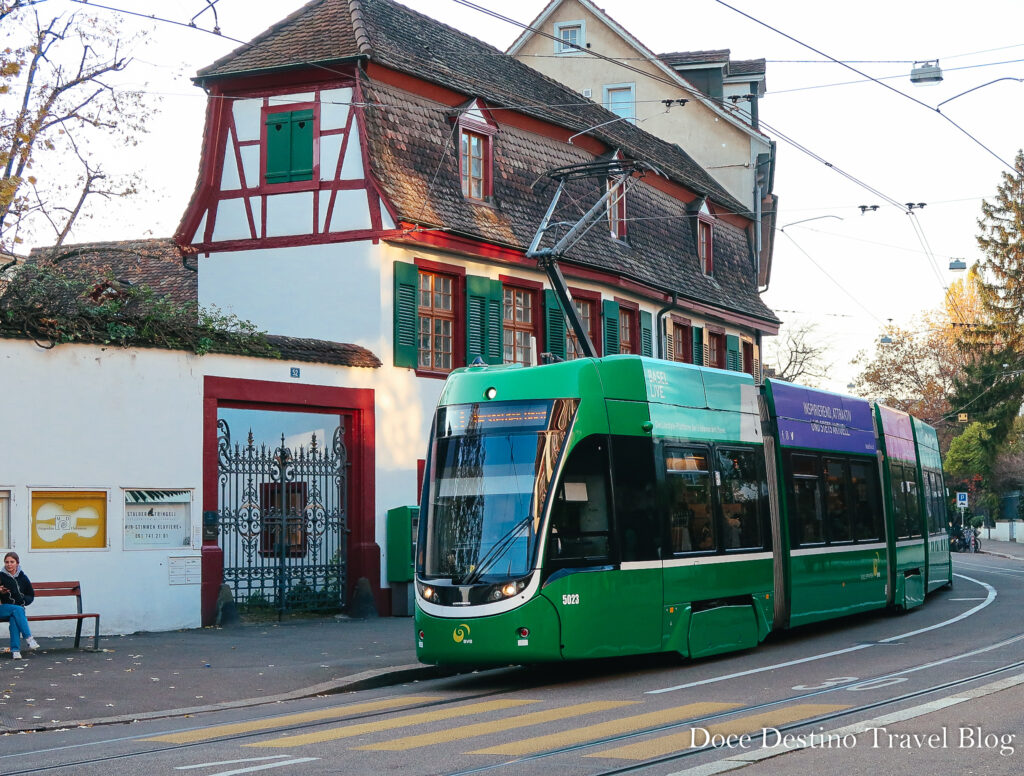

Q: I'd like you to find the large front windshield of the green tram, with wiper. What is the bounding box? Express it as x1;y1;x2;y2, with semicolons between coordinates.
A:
421;399;578;585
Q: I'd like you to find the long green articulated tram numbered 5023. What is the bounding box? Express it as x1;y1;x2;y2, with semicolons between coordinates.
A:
416;355;952;665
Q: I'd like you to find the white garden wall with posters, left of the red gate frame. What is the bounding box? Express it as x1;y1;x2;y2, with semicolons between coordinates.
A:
0;340;203;637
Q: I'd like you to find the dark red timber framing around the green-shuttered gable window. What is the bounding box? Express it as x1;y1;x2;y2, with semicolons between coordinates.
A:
175;73;395;253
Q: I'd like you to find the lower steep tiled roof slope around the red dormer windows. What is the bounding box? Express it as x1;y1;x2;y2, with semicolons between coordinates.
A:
362;81;775;320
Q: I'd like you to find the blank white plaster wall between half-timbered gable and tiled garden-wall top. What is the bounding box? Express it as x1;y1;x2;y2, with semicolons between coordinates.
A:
199;241;380;343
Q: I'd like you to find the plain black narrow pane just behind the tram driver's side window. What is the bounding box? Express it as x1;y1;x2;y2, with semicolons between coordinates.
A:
611;436;662;561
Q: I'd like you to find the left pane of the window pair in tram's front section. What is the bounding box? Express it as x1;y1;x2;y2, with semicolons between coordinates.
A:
665;447;716;553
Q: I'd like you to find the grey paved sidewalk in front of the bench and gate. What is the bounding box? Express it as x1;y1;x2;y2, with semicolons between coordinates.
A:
0;617;451;732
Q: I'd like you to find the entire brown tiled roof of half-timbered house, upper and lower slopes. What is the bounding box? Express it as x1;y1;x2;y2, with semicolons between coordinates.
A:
197;0;776;321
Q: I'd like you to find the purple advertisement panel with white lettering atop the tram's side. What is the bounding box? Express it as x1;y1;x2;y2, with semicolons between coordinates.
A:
771;382;878;454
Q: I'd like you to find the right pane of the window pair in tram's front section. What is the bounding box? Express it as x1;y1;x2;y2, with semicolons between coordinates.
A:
716;448;768;550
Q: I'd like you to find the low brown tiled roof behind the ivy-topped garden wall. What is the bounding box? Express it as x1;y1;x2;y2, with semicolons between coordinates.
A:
28;238;199;304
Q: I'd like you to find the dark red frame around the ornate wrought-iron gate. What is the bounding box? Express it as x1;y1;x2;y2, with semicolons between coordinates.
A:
201;377;382;626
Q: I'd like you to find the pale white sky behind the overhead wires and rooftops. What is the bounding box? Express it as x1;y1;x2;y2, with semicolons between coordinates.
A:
16;0;1024;391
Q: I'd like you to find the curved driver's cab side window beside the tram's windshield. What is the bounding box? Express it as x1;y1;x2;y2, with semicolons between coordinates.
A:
548;436;610;565
